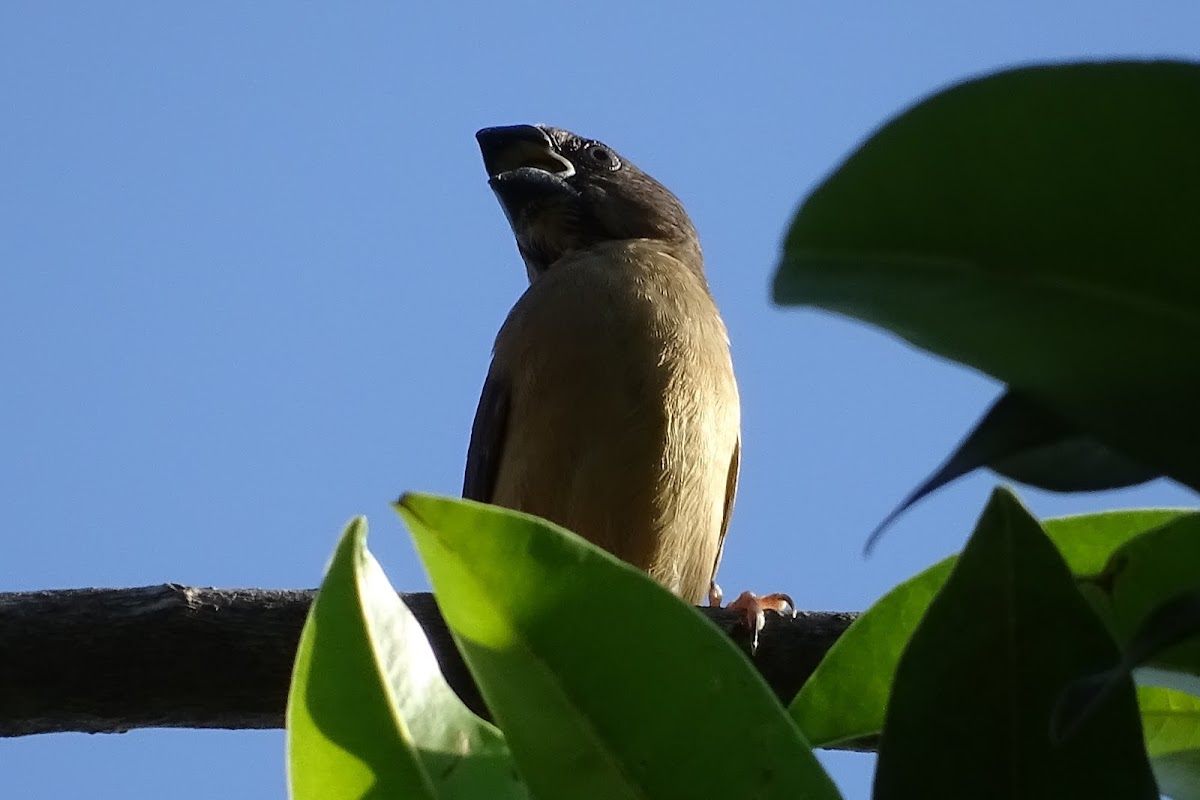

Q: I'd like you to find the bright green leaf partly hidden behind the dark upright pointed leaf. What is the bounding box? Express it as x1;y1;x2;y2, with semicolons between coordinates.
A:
790;510;1186;747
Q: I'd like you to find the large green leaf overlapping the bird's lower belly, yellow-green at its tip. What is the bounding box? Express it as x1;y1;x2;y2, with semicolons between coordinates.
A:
398;494;839;800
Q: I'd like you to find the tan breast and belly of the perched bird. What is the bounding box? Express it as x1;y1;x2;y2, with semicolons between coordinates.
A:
494;248;739;601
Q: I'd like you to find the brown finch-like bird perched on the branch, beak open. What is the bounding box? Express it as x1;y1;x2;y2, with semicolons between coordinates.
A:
463;125;794;631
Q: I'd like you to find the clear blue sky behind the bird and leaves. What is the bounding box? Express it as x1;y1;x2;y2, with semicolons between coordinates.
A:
0;0;1200;800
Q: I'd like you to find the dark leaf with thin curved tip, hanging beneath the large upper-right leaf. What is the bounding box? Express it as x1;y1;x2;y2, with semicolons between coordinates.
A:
865;391;1157;553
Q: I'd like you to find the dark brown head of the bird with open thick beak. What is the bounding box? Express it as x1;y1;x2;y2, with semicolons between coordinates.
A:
475;125;700;281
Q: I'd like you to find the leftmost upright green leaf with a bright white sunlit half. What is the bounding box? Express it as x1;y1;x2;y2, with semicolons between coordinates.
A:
287;517;528;800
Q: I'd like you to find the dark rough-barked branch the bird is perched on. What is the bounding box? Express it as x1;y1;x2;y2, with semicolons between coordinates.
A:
0;584;854;736
